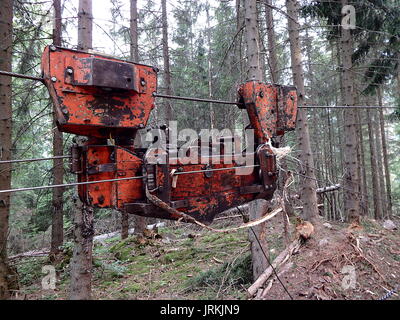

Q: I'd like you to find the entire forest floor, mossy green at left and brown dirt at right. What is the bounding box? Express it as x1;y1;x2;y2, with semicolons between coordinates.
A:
10;212;400;300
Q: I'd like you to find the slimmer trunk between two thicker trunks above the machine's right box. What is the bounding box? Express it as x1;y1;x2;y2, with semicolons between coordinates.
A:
265;0;280;83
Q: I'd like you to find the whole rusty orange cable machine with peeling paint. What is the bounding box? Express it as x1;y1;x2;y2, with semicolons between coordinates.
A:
42;45;297;223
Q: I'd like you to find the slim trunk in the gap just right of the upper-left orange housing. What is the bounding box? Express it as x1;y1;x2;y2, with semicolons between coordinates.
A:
161;0;172;124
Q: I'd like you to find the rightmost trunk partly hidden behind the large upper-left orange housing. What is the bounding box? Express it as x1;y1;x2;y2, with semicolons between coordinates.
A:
126;0;146;239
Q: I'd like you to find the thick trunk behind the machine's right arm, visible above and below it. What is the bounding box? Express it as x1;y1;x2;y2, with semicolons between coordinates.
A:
244;0;269;279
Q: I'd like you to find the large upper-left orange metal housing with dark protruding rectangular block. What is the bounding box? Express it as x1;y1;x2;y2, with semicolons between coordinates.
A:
42;47;157;138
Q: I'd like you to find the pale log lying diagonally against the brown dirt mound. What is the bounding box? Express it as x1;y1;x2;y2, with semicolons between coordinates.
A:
247;238;302;297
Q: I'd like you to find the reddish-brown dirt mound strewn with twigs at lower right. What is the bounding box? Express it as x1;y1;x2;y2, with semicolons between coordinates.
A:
260;215;400;300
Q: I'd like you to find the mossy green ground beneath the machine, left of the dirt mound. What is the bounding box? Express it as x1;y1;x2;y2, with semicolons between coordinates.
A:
11;227;272;299
